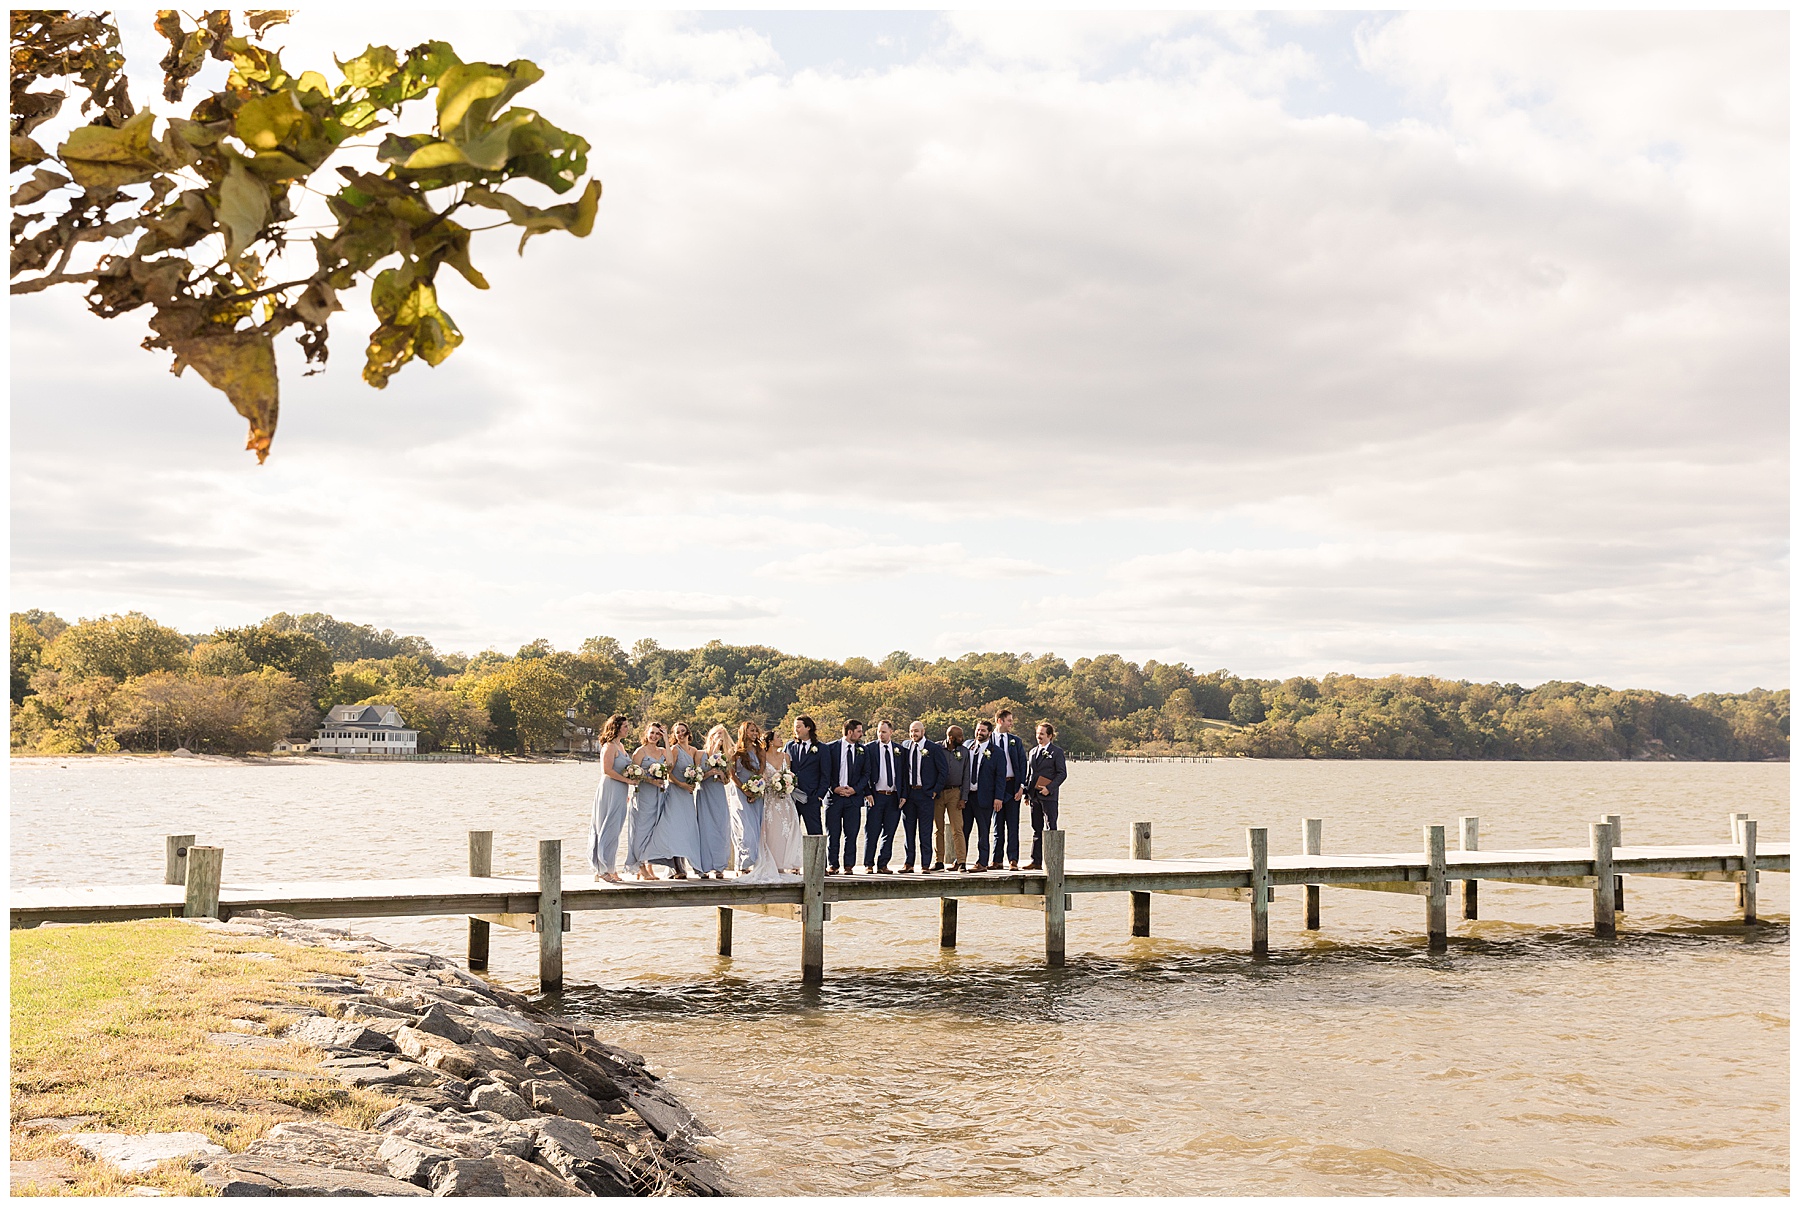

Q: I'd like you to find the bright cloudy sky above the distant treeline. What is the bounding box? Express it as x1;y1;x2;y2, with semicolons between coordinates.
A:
11;9;1789;693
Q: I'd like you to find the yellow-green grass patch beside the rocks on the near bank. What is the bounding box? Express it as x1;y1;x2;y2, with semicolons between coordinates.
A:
11;919;394;1194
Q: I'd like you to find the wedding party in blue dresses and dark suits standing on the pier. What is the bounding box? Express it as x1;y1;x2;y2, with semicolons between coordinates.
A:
589;709;1069;883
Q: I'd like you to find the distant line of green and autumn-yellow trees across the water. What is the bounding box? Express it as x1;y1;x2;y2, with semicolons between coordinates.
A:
13;612;1787;759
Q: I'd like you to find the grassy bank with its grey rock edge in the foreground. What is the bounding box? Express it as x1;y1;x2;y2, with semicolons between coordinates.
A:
11;910;731;1198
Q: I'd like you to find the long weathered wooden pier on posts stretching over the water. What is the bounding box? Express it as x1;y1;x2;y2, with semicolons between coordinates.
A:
11;813;1789;993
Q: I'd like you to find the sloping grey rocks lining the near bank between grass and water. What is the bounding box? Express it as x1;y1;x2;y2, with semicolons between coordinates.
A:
173;910;734;1198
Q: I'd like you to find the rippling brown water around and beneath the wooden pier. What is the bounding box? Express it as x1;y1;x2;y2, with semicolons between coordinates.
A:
11;759;1789;1194
